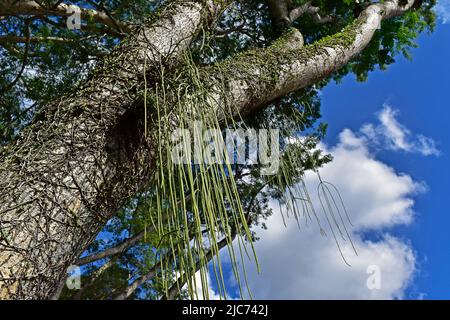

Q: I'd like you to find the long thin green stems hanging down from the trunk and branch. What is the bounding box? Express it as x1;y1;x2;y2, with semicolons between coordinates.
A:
139;51;356;299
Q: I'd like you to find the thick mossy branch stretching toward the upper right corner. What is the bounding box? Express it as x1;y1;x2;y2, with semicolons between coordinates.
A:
203;0;414;119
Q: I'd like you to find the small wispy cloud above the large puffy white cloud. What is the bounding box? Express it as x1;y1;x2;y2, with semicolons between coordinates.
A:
359;105;440;156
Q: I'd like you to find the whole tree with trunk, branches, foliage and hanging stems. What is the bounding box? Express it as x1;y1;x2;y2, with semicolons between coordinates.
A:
0;0;435;299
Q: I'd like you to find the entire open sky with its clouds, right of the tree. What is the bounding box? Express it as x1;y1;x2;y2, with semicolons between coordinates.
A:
201;5;450;299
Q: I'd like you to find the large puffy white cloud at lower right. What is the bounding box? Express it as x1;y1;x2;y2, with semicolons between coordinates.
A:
219;130;424;299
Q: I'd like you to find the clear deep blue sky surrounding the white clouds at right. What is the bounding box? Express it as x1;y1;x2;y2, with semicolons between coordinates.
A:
322;16;450;299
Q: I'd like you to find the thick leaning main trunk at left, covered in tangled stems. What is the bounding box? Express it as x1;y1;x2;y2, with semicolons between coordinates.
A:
0;1;225;299
